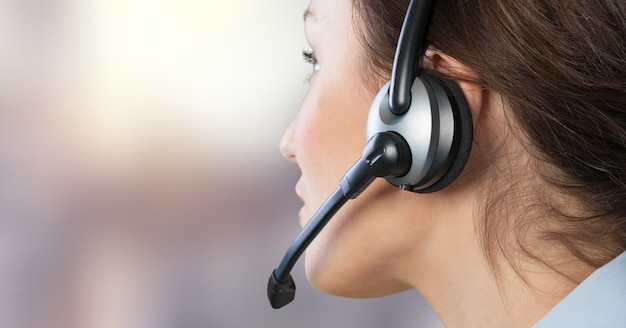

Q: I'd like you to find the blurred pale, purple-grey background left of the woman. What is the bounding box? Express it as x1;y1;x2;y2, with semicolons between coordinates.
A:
0;0;441;328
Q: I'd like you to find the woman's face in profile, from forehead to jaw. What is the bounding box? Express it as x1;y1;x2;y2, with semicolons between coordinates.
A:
281;0;438;297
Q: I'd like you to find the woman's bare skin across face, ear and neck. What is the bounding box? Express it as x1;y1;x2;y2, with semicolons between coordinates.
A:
280;0;588;327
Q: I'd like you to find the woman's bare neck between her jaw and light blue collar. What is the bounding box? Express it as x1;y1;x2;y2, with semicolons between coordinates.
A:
398;191;575;327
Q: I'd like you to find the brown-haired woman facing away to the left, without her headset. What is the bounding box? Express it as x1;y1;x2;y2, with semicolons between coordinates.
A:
281;0;626;327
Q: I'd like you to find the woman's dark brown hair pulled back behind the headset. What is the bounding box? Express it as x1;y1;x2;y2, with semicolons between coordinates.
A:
355;0;626;274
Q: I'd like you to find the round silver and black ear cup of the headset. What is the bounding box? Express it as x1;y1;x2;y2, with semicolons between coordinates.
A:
367;74;473;193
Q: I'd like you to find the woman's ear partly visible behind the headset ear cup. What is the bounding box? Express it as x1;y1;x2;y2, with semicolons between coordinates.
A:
424;47;482;123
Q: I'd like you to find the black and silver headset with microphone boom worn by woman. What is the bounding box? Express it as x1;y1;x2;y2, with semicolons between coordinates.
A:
267;0;473;309
